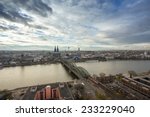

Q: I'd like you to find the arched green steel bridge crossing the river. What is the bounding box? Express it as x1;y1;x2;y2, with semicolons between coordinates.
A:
60;60;90;79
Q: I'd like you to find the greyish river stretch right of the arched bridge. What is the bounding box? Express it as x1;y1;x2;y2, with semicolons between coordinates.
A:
76;60;150;75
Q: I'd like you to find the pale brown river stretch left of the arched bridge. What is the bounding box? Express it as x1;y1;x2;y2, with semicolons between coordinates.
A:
0;64;72;90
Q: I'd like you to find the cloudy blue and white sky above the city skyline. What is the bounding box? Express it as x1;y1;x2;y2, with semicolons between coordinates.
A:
0;0;150;50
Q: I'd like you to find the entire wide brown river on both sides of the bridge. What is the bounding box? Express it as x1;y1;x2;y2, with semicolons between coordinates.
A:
0;61;150;90
